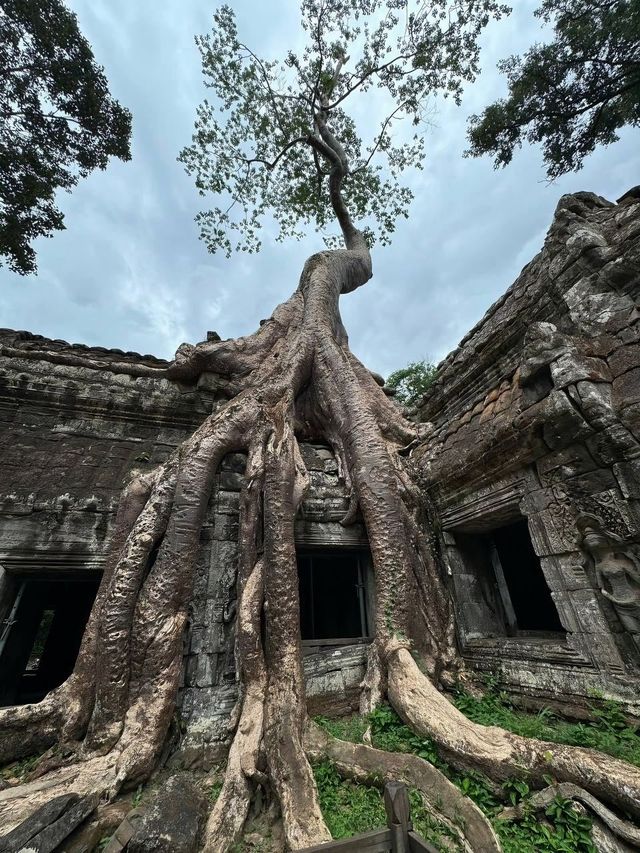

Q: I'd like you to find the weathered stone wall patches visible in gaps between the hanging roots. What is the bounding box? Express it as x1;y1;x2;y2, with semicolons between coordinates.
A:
173;444;367;766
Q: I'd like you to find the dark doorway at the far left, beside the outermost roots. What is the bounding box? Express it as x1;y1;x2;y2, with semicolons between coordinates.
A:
0;573;99;706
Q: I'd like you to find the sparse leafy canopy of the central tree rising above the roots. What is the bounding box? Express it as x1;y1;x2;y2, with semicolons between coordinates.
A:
179;0;508;256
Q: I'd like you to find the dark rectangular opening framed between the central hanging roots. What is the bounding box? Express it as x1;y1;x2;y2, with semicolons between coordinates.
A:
298;549;369;641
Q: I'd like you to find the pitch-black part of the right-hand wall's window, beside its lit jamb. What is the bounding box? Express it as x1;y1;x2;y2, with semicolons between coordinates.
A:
488;518;564;633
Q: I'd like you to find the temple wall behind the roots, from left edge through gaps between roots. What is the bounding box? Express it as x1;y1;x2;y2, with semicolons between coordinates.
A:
0;330;366;764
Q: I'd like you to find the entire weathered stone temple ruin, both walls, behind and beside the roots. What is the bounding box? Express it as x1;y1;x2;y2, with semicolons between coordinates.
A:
0;189;640;767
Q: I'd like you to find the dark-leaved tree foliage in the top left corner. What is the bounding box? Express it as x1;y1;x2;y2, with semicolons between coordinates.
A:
0;0;131;275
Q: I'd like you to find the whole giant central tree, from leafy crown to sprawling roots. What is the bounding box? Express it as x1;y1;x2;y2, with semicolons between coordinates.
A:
0;0;640;851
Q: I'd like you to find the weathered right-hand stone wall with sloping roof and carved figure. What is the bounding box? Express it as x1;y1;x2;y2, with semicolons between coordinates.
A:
416;191;640;710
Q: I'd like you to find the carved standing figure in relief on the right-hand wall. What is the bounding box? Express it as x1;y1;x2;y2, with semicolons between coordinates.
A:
577;514;640;643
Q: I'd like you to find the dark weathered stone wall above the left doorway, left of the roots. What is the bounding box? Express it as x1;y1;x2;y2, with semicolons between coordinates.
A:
0;330;202;569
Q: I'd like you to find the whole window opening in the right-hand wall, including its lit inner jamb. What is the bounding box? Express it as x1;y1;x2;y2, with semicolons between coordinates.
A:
455;517;566;640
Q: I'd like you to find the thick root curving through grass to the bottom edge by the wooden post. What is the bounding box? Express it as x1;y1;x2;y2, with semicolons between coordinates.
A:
305;722;501;853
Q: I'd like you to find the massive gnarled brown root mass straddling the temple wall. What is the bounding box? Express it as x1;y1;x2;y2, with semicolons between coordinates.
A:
0;230;640;851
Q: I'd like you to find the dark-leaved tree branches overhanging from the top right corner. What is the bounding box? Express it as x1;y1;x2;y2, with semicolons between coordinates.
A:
468;0;640;180
